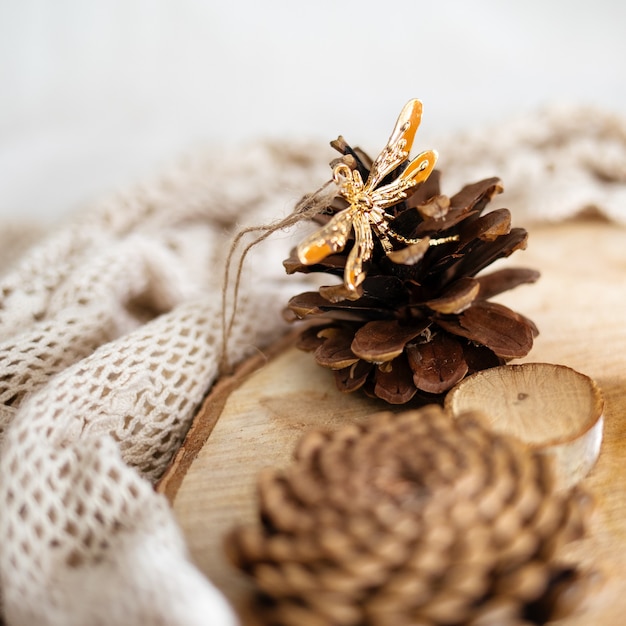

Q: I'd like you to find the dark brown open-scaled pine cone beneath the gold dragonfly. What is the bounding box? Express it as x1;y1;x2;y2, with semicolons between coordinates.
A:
284;166;539;404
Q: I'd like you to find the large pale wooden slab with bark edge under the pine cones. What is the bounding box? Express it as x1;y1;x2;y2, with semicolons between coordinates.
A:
160;220;626;626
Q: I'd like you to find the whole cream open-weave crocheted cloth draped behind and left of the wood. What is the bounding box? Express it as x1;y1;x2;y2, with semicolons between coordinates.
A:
0;105;626;626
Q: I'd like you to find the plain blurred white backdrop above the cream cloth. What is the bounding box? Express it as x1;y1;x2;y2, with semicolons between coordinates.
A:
0;0;626;220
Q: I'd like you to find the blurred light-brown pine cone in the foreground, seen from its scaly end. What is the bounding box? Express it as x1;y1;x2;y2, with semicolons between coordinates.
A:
226;405;590;626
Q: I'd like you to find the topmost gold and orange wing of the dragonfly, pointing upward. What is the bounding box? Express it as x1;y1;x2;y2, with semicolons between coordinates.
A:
366;99;422;190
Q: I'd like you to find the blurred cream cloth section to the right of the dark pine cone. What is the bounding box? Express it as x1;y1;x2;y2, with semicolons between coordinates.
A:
436;104;626;223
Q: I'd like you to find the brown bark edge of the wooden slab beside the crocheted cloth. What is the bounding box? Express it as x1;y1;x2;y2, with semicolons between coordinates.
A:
155;329;302;504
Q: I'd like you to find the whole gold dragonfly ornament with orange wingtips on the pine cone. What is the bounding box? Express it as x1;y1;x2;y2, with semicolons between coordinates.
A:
297;99;456;295
